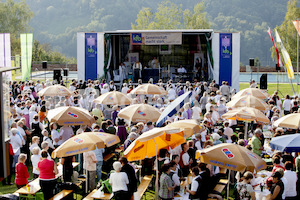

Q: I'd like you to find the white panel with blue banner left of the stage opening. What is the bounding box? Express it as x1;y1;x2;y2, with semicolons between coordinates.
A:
77;33;104;80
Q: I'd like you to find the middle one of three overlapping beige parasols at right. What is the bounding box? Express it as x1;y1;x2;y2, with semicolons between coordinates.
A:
226;95;269;111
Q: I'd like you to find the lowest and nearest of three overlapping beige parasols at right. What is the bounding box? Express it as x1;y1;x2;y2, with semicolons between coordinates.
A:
221;107;270;123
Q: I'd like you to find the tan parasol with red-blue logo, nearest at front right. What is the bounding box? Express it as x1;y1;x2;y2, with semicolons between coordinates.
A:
196;143;267;172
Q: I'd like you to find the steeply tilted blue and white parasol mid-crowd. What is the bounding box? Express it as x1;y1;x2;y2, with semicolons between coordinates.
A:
156;91;192;127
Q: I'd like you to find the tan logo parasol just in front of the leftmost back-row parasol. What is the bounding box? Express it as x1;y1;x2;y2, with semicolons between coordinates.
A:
47;106;95;125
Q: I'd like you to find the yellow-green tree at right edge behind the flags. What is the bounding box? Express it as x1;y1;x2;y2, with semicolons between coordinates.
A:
271;0;300;62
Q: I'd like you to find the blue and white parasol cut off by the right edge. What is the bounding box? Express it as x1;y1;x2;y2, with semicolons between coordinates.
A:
269;133;300;152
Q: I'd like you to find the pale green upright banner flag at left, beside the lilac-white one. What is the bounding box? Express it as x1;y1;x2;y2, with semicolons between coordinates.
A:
20;33;33;81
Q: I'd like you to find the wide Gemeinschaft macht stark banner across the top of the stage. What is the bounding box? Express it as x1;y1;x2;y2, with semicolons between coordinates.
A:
130;32;182;45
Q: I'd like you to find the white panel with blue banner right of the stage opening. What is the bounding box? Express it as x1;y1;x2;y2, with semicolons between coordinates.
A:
212;33;240;91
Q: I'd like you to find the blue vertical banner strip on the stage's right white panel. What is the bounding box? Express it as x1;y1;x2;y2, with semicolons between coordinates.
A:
219;33;232;86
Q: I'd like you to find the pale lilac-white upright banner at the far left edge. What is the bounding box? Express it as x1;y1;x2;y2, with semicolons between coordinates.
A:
0;33;12;80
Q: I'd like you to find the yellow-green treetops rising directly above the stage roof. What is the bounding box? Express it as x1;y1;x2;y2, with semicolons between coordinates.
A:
131;1;210;30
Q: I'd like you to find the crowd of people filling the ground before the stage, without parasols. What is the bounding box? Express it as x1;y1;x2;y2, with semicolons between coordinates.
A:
3;79;300;200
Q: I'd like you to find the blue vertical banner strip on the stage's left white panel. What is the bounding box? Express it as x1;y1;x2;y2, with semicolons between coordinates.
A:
85;33;97;80
